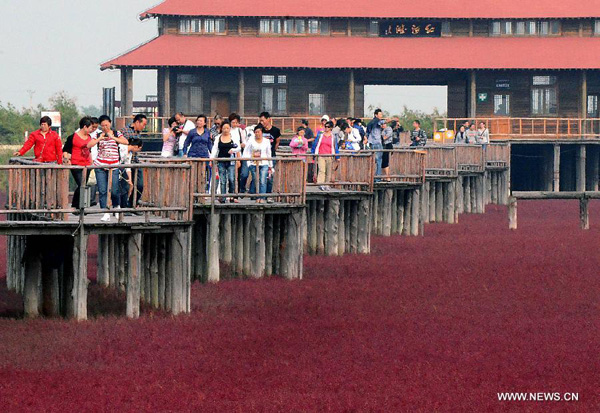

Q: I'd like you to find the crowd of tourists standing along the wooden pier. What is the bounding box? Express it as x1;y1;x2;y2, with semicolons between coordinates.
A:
14;109;489;211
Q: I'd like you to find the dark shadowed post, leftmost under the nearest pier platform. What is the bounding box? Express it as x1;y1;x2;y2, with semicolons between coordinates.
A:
23;243;42;317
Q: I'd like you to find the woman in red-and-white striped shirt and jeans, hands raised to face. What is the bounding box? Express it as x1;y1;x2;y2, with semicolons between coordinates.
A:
88;115;129;222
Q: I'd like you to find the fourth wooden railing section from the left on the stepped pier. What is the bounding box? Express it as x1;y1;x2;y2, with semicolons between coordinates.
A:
373;149;427;184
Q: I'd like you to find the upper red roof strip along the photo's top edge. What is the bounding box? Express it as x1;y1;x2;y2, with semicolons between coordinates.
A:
140;0;600;19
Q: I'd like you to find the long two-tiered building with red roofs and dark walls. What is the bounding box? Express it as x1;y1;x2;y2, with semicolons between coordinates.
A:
101;0;600;118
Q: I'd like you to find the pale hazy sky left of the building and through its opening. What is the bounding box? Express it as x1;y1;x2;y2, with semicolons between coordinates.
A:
0;0;446;114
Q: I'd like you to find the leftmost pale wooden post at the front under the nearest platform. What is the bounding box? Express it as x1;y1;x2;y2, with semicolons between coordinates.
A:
69;232;88;320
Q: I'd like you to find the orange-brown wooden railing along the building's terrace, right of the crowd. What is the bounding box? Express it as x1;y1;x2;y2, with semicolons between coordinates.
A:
434;117;600;140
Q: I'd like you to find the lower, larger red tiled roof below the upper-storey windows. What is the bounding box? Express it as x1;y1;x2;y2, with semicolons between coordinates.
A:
101;35;600;70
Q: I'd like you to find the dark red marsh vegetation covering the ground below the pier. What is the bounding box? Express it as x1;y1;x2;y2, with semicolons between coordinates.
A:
0;201;600;412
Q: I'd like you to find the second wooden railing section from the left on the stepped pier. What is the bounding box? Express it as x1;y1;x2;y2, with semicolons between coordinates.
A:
141;154;306;206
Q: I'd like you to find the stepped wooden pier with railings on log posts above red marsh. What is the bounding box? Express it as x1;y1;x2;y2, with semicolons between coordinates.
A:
0;144;510;320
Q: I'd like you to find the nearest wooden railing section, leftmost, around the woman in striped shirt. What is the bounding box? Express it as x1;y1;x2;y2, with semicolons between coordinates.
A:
0;158;193;222
